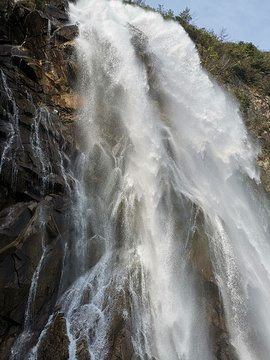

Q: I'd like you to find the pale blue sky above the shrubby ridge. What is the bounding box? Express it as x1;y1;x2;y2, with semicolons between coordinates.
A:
145;0;270;51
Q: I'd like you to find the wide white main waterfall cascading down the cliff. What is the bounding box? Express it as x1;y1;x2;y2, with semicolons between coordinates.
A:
21;0;270;360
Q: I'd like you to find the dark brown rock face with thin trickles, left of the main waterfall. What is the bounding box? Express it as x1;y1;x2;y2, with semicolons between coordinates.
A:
0;0;79;359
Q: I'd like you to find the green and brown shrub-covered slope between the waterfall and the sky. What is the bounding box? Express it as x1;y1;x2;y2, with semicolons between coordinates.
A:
125;0;270;193
